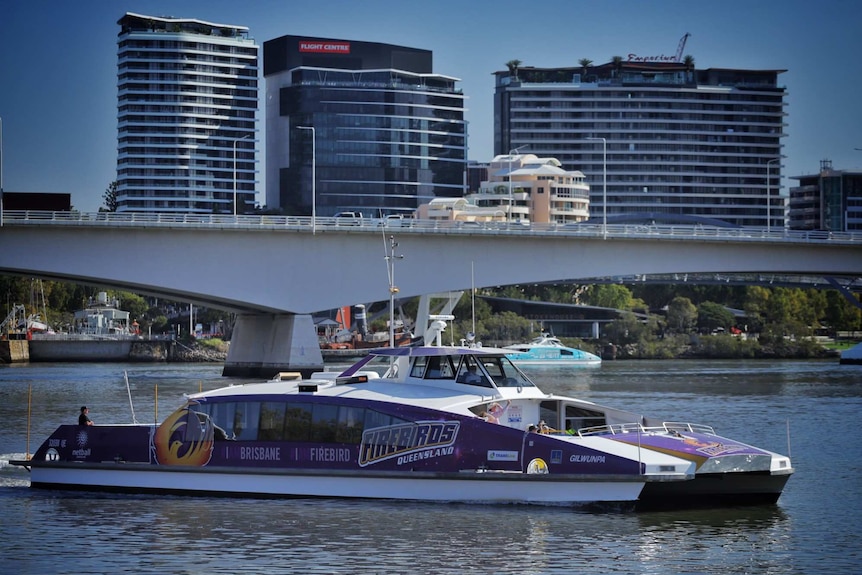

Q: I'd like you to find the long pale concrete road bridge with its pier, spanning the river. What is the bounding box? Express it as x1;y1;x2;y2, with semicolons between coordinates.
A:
0;211;862;375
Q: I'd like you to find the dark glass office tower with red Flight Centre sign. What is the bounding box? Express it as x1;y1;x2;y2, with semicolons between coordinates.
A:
263;36;466;216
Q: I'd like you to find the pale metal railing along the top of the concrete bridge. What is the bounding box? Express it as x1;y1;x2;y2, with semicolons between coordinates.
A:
0;210;862;244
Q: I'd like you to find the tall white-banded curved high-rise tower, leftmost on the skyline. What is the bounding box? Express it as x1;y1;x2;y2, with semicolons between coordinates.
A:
117;13;259;214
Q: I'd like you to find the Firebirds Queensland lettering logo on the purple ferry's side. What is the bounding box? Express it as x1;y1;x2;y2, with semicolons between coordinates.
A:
359;421;461;467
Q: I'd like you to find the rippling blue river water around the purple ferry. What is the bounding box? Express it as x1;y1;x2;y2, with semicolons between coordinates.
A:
0;360;862;575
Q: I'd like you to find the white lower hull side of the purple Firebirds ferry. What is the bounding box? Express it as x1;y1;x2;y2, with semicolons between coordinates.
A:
20;462;652;505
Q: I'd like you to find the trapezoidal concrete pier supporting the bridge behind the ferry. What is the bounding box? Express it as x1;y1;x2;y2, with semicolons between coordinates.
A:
222;314;323;379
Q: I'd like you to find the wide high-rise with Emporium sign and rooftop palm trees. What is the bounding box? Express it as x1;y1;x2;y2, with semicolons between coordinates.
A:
494;57;785;228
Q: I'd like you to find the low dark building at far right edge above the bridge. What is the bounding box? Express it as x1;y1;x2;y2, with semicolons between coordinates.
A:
788;160;862;232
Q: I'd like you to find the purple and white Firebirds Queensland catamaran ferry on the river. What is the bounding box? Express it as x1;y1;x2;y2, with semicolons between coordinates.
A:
11;332;793;506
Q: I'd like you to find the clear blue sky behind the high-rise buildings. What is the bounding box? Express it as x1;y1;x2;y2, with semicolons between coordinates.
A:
0;0;862;211
